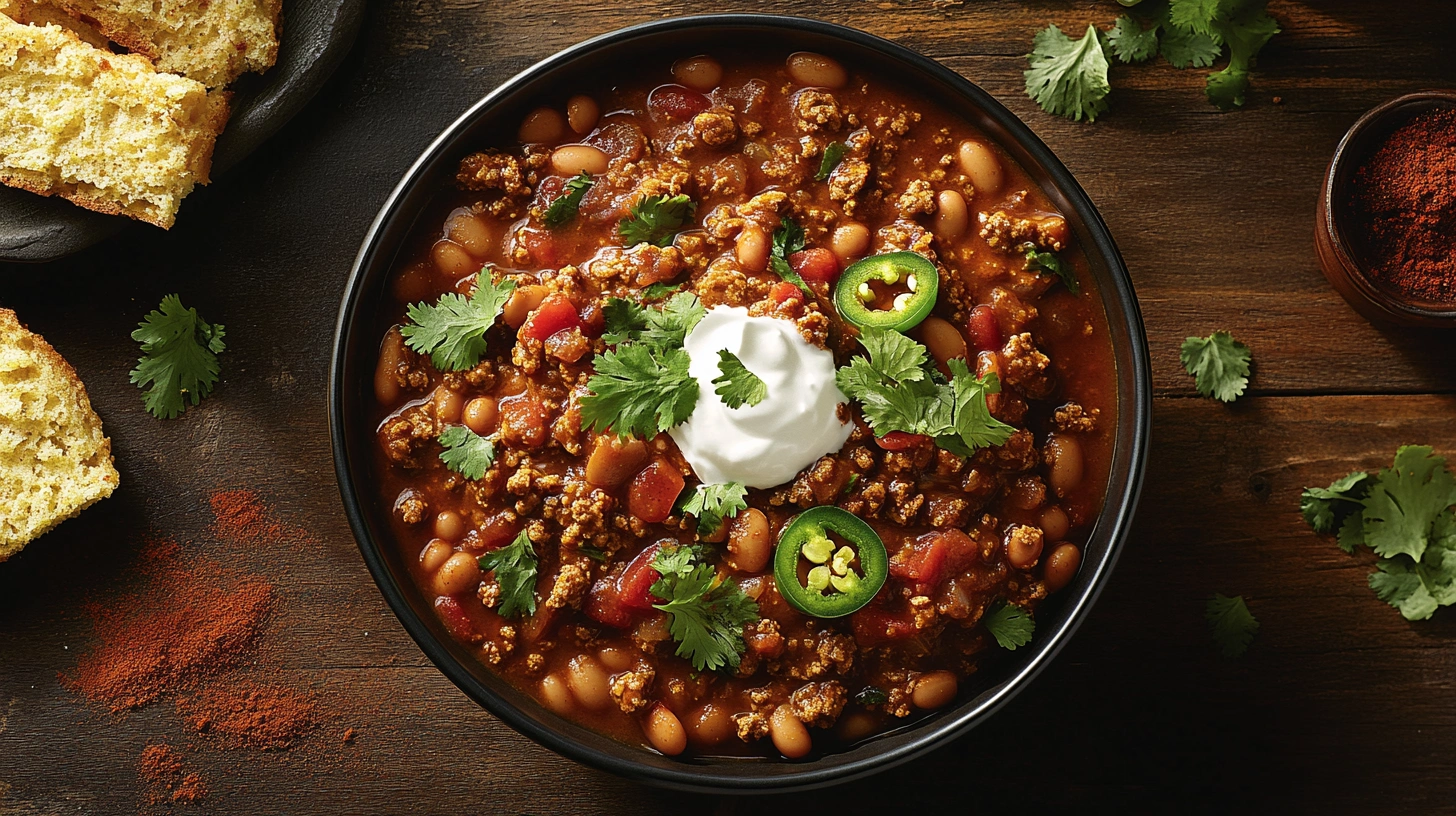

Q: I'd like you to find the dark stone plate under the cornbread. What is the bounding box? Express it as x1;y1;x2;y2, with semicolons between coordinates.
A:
0;0;364;262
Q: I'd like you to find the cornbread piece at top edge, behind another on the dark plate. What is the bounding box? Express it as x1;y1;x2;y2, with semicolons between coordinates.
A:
26;0;282;87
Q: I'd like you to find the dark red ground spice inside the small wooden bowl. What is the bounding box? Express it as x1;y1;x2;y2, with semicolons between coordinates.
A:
1353;108;1456;302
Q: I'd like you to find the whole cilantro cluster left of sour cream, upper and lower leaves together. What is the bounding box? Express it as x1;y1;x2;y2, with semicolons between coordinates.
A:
581;291;708;439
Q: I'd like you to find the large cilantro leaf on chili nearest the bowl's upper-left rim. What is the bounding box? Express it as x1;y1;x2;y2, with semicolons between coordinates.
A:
399;268;515;372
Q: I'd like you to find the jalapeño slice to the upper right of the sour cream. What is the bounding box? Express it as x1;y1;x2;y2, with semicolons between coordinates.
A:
834;252;941;332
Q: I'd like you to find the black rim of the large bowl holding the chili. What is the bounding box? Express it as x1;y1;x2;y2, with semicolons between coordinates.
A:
329;13;1152;794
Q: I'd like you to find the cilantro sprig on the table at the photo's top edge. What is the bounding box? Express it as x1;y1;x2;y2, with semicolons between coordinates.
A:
1026;0;1280;121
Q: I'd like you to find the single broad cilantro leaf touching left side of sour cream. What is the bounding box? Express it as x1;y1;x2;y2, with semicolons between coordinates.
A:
581;342;697;439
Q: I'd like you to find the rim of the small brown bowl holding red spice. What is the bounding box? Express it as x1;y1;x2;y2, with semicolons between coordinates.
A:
1319;87;1456;319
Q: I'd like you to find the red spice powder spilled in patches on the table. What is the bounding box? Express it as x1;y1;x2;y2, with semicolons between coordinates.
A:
60;490;333;804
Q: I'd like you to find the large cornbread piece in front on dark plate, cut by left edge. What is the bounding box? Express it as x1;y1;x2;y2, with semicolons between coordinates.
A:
0;16;227;227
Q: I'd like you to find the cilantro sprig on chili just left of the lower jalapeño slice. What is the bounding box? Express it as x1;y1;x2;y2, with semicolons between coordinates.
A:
652;549;759;672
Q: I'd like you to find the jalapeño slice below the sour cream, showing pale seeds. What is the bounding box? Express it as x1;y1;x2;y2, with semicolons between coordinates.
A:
773;507;890;618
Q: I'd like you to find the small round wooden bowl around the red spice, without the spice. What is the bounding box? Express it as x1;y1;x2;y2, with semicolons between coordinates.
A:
1315;90;1456;328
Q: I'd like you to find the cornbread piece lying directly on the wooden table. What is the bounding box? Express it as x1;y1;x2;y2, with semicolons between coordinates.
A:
0;309;119;561
